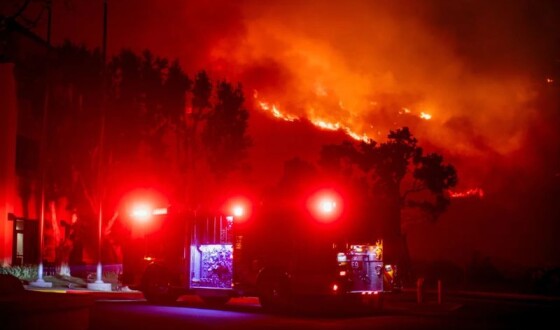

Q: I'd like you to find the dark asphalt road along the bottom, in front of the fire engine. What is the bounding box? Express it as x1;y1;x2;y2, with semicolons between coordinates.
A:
90;296;560;330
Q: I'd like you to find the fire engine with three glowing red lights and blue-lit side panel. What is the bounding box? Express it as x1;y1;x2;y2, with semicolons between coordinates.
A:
123;189;396;310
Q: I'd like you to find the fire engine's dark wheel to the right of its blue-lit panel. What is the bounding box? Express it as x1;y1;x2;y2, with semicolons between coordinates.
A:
258;274;291;312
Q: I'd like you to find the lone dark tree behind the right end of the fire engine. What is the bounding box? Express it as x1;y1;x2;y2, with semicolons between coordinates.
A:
320;127;457;282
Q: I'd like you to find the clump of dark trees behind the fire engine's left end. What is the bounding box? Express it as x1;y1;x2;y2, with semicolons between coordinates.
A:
17;41;250;270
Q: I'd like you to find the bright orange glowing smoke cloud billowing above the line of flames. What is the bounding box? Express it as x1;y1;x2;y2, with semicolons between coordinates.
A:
213;1;552;154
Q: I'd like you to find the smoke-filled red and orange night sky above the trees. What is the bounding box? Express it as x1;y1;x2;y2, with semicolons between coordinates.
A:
15;0;560;266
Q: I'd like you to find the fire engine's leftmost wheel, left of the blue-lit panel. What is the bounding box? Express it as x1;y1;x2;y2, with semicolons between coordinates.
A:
141;266;179;304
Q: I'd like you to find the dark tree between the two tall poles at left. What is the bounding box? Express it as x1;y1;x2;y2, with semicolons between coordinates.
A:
43;41;103;266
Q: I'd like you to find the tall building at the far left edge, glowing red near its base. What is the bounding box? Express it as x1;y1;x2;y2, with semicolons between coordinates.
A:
0;16;49;266
